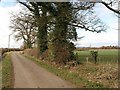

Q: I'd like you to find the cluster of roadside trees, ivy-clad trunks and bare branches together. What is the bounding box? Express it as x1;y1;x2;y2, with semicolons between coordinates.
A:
10;0;119;64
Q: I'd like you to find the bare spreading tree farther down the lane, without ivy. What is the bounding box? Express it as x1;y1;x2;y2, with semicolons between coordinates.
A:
10;11;37;48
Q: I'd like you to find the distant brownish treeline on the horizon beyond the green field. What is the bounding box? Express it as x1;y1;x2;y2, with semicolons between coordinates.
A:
76;46;120;50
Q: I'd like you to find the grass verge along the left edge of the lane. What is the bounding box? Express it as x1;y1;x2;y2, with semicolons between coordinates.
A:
2;54;13;88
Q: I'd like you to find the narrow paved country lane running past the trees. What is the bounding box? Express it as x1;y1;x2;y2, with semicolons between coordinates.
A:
12;52;73;88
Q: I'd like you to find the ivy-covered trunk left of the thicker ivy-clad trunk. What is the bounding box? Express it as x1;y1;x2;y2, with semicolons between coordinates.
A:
34;6;48;55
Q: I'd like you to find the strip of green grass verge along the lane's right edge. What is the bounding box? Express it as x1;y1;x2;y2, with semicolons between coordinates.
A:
25;55;104;88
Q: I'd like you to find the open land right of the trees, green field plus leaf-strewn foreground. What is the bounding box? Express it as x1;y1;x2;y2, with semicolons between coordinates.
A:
73;49;118;88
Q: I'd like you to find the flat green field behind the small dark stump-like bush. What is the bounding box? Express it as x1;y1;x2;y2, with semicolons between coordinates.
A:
75;49;118;63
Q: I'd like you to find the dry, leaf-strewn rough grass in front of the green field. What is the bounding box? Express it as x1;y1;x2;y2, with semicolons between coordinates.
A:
71;63;118;88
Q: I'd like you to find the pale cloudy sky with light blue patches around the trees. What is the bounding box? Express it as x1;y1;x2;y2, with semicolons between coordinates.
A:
0;0;118;48
